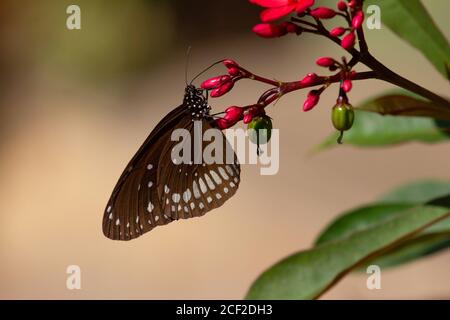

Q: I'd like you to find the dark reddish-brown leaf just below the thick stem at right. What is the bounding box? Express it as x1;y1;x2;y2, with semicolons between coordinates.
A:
357;94;450;121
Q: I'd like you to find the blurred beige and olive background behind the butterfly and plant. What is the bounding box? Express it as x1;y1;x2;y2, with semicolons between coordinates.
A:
0;0;450;299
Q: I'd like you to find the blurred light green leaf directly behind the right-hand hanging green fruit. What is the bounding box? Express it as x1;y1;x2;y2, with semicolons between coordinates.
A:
316;110;450;151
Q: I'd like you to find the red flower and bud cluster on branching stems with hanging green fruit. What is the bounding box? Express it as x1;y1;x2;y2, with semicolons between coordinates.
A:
201;0;365;142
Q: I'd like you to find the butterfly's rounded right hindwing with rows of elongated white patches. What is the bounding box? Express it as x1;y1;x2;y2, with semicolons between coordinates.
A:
158;118;240;220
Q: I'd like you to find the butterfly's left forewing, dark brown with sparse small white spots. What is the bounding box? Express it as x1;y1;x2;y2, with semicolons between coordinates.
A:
102;105;186;240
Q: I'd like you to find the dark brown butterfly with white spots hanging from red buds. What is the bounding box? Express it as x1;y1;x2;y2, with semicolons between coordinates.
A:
103;85;240;240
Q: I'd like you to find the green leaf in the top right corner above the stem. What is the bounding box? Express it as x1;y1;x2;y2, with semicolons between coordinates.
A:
374;0;450;78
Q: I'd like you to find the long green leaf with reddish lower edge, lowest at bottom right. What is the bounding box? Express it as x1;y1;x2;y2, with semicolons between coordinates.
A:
246;206;449;299
